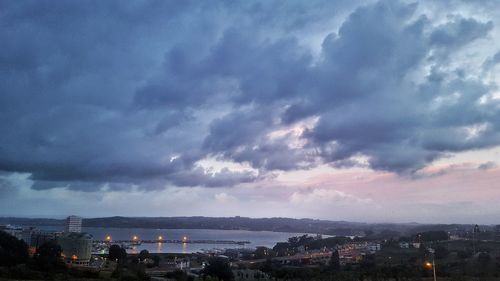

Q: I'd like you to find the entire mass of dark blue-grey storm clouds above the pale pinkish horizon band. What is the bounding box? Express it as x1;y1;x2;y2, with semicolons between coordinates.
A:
0;1;500;191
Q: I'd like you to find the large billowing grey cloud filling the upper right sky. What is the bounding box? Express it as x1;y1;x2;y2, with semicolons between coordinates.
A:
300;2;499;174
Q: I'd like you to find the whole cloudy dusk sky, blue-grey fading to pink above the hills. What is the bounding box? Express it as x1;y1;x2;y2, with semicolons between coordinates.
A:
0;0;500;224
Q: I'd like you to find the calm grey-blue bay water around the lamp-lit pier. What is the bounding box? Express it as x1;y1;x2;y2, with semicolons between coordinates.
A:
37;227;304;253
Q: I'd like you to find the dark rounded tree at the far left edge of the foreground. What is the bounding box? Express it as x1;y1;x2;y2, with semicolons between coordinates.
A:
0;231;28;266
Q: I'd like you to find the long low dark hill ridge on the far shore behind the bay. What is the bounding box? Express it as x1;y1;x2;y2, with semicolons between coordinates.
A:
0;216;478;235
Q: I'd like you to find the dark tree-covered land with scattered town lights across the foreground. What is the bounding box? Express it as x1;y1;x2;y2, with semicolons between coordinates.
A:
0;225;500;281
